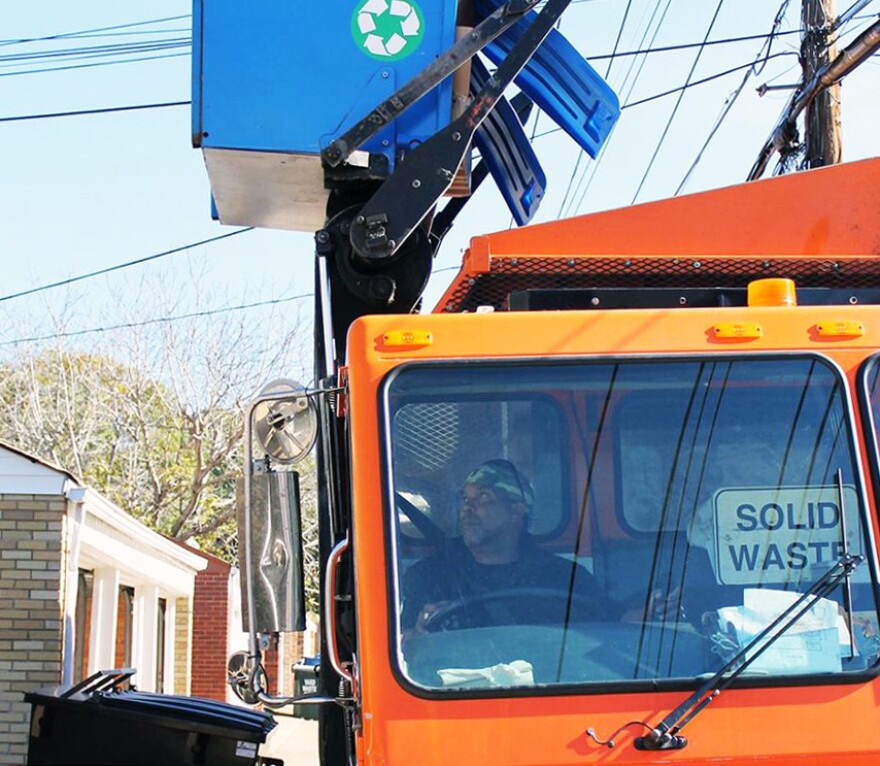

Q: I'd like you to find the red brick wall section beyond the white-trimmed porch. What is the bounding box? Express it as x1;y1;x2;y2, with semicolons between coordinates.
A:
192;553;232;700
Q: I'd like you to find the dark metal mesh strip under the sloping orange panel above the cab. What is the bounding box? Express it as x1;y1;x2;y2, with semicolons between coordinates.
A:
440;256;880;312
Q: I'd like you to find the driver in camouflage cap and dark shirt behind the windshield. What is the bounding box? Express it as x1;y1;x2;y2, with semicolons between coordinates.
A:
401;460;602;636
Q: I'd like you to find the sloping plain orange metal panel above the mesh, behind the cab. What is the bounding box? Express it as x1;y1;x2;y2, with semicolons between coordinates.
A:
468;159;880;257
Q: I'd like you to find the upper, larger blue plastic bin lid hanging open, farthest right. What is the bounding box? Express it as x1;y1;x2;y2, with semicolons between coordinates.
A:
474;0;620;159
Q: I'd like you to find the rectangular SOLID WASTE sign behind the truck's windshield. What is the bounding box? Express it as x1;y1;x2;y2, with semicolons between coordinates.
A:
715;486;861;585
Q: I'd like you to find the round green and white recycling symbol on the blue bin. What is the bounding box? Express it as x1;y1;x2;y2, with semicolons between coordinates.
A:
351;0;425;61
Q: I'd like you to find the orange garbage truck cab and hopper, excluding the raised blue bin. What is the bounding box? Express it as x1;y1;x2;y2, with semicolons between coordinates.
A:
235;160;880;766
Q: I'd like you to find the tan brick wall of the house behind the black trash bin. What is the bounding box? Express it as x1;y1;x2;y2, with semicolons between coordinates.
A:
0;495;67;766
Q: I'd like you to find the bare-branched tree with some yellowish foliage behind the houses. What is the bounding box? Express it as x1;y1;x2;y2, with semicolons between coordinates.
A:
0;268;314;580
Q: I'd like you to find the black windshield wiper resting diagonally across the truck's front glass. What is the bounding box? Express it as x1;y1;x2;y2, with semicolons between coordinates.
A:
587;550;865;750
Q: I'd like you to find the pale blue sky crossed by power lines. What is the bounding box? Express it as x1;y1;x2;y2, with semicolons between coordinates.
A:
0;0;880;366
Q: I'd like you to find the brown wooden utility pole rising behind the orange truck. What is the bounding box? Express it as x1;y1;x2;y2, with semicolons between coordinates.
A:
801;0;841;168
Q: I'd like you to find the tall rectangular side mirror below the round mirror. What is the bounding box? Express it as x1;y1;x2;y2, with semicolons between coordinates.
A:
238;471;306;633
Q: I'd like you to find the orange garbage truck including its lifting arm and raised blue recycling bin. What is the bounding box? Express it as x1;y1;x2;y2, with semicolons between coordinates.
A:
205;0;880;766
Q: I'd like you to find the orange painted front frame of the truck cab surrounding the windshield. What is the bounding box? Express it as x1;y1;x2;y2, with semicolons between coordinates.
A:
349;306;880;766
